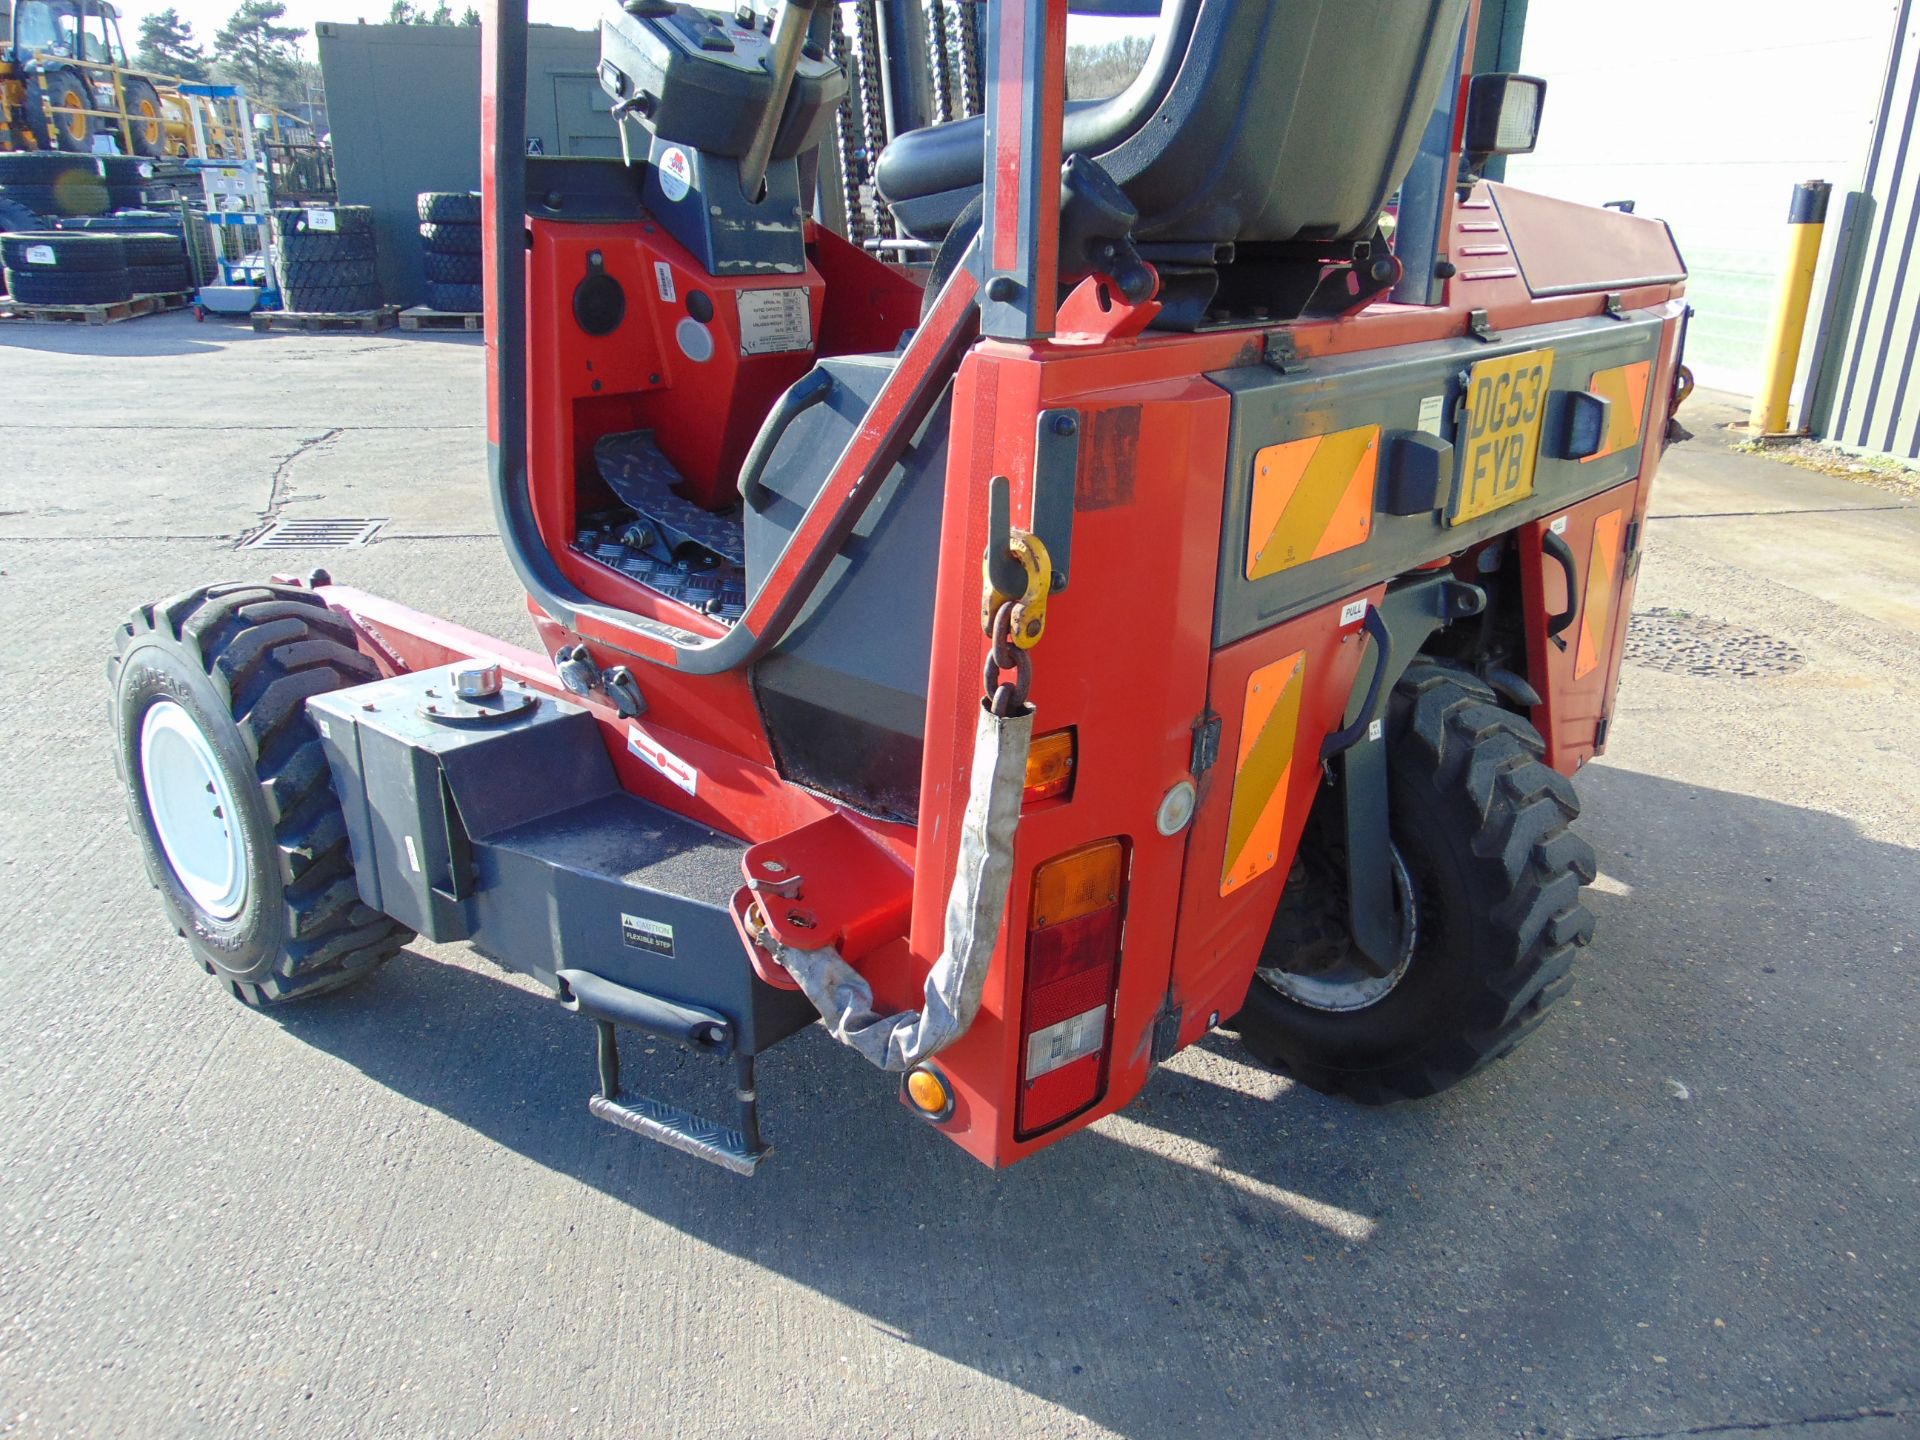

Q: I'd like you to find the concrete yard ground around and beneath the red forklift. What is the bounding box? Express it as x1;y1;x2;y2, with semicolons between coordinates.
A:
0;317;1920;1440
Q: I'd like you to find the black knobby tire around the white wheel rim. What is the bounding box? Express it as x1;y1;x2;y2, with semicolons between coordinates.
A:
108;584;413;1006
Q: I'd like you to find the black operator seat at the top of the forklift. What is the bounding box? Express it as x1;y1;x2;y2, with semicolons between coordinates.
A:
874;0;1467;246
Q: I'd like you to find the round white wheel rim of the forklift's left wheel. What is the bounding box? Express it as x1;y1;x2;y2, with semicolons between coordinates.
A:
140;701;248;920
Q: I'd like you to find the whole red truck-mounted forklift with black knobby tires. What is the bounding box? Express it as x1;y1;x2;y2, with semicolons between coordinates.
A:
108;0;1686;1173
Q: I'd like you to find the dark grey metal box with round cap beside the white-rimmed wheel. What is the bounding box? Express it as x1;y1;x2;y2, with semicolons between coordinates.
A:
307;666;814;1054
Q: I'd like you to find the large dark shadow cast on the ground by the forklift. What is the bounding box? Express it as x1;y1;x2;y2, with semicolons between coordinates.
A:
263;766;1920;1440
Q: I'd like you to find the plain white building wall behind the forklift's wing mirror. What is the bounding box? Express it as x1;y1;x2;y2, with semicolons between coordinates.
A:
1507;0;1899;396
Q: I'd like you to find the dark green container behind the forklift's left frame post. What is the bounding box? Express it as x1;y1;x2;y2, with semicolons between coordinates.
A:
315;21;620;305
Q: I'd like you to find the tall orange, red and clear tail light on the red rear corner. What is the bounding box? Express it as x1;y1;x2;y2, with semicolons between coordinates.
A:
1018;839;1127;1139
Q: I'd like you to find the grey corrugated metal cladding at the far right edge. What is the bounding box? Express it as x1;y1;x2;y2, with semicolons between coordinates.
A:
1816;0;1920;459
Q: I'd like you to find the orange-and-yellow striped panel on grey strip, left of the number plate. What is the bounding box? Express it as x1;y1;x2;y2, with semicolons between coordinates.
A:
1246;424;1380;580
